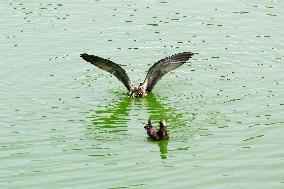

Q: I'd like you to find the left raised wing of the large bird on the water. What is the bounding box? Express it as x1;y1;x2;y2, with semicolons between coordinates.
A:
80;53;131;91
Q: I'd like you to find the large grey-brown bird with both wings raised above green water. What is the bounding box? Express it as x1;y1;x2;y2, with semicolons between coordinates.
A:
80;52;196;98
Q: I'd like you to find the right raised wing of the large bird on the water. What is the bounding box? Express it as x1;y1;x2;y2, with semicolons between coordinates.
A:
143;52;194;92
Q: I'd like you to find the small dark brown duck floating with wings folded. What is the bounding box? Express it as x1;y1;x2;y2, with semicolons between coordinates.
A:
144;119;170;140
